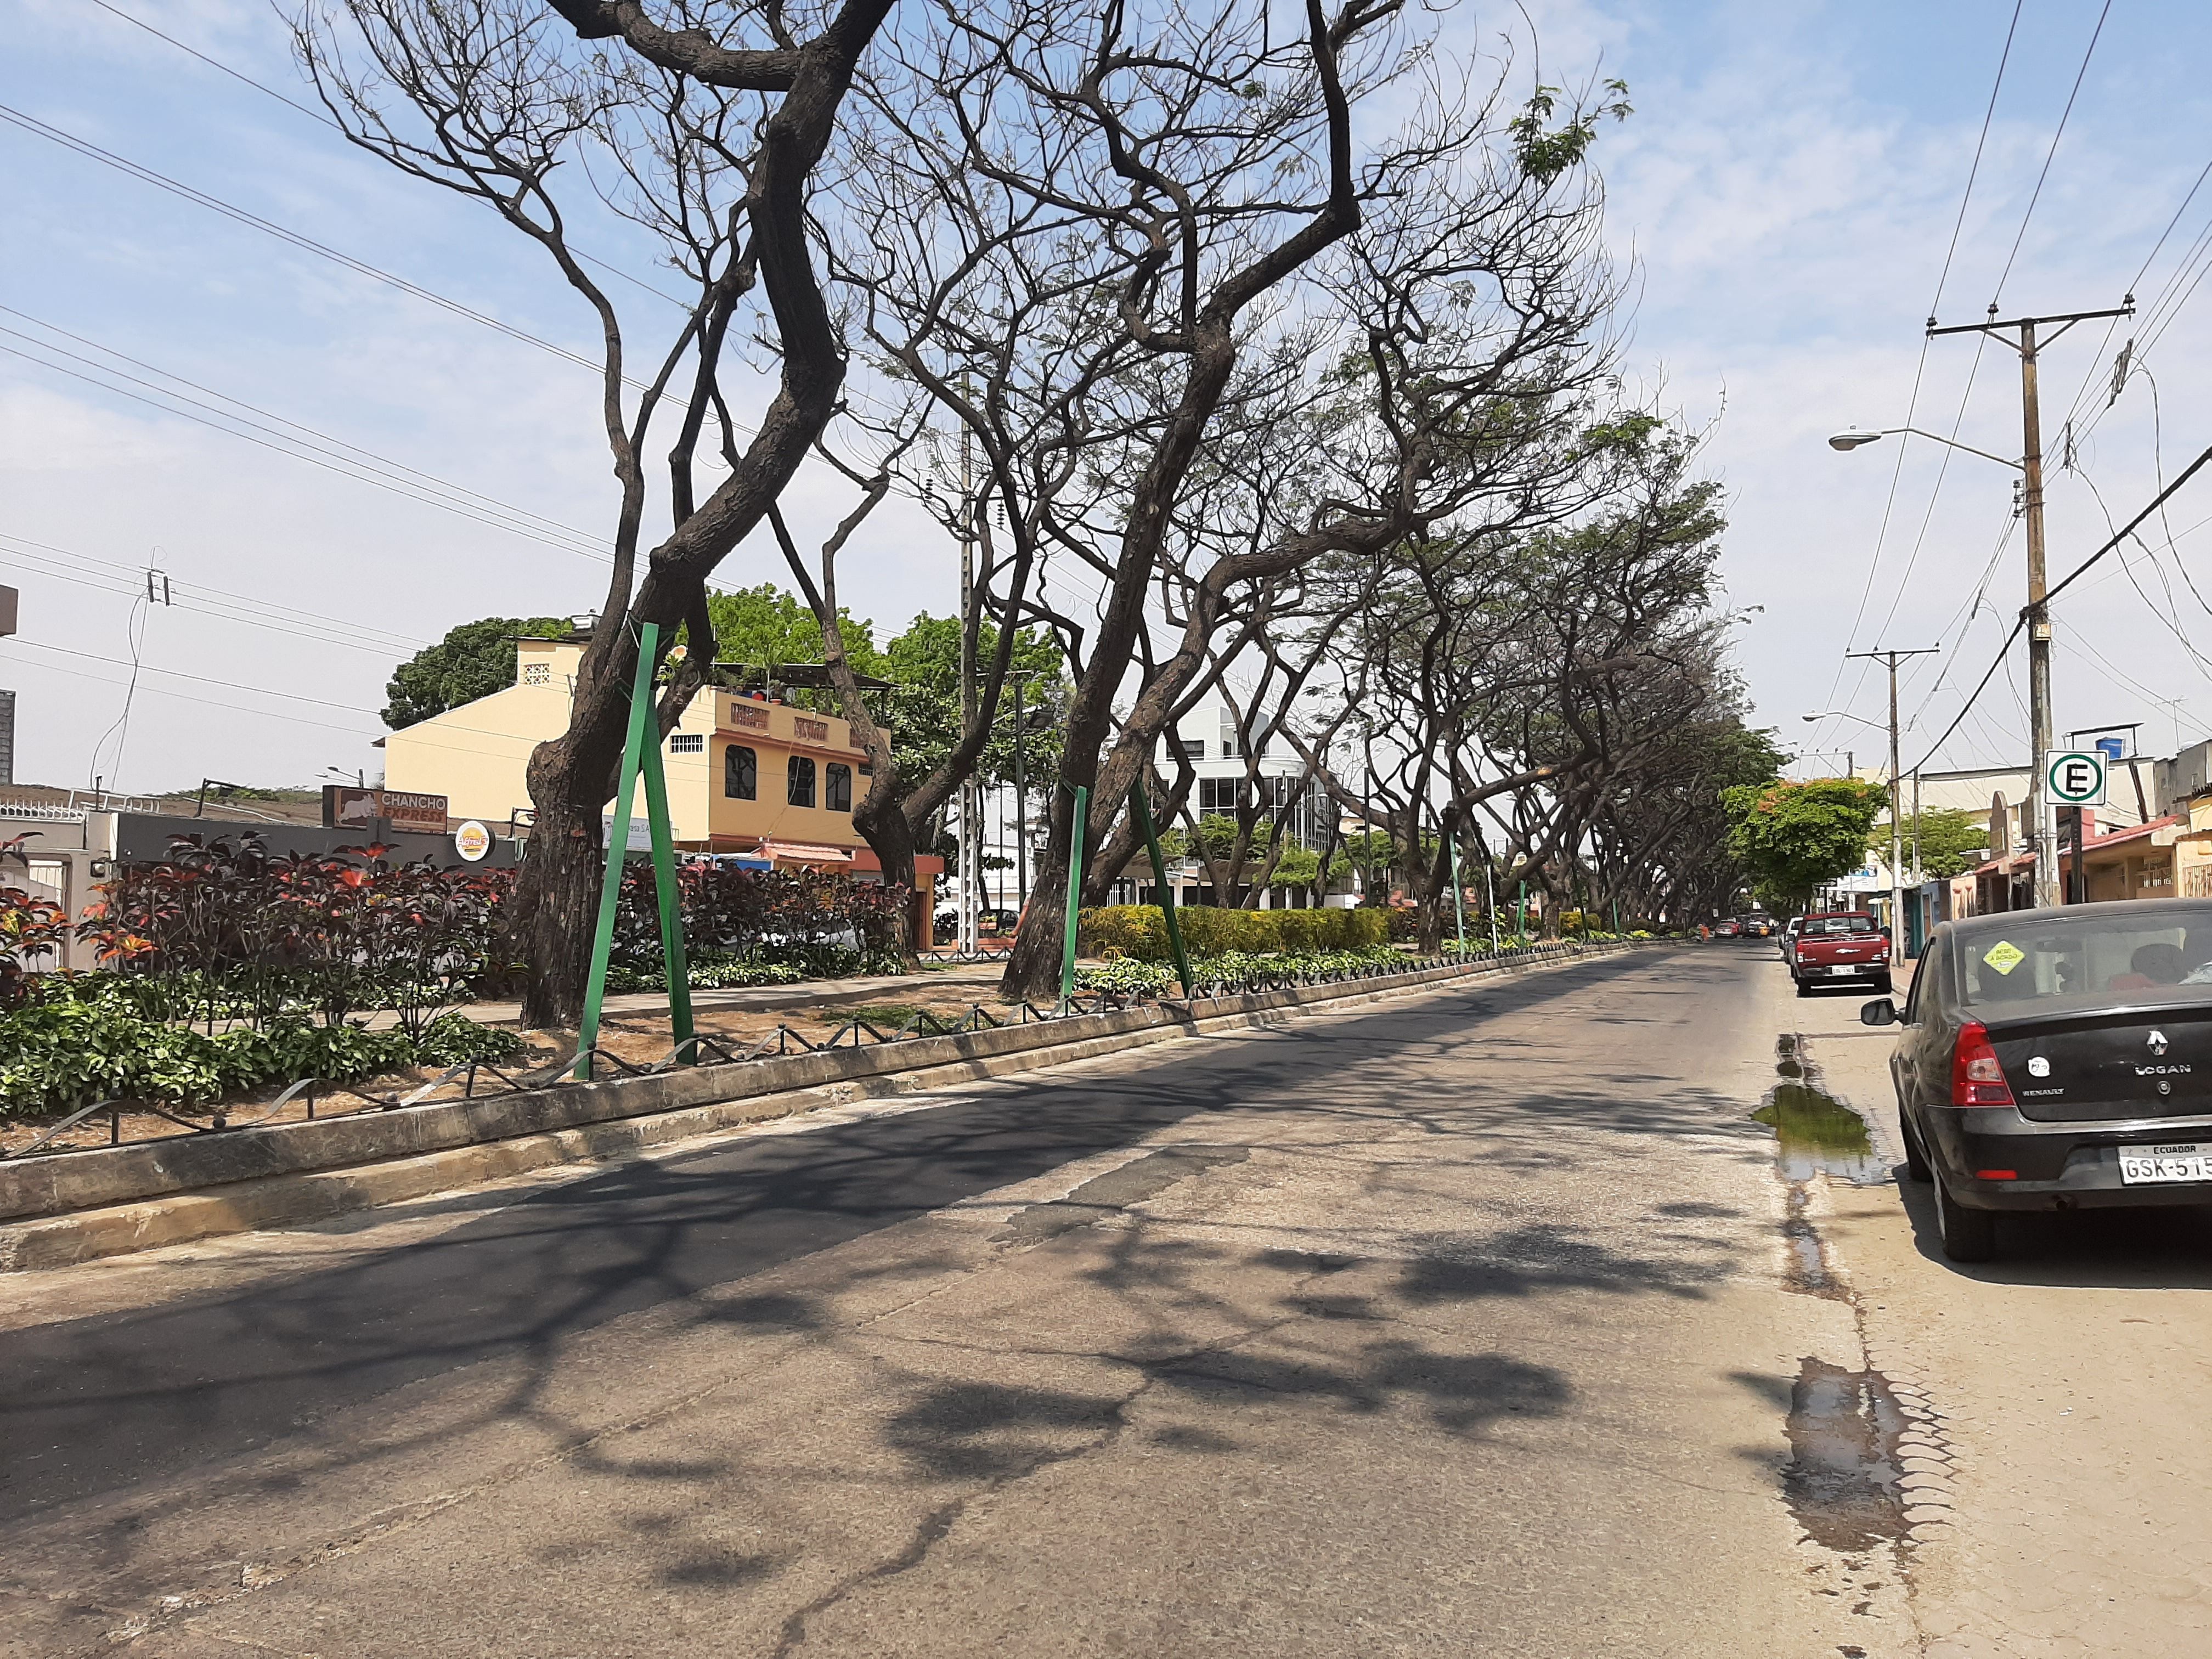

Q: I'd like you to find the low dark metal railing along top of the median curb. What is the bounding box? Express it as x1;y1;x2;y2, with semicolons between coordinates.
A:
0;943;1628;1164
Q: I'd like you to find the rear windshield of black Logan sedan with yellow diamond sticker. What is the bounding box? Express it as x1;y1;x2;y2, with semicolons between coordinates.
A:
1957;900;2212;1007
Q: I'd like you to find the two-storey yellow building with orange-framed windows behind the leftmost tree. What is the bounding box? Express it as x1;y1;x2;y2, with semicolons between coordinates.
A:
385;637;945;898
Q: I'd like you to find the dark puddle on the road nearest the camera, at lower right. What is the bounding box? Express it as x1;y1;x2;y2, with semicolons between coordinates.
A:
1783;1358;1905;1555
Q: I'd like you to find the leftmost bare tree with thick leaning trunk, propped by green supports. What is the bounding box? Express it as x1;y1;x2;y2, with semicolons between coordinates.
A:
294;0;891;1026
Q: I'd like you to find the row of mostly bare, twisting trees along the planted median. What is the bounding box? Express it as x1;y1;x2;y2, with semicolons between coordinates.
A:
294;0;1741;1024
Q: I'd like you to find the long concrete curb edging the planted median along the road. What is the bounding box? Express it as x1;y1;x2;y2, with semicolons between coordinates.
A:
0;945;1633;1272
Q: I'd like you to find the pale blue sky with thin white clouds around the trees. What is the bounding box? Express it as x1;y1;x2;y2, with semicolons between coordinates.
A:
0;0;2212;792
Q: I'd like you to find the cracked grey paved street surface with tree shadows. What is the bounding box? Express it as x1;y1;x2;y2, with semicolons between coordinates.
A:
0;943;2212;1659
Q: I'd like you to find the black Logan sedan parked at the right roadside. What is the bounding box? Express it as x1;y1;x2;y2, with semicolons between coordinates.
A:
1860;898;2212;1261
